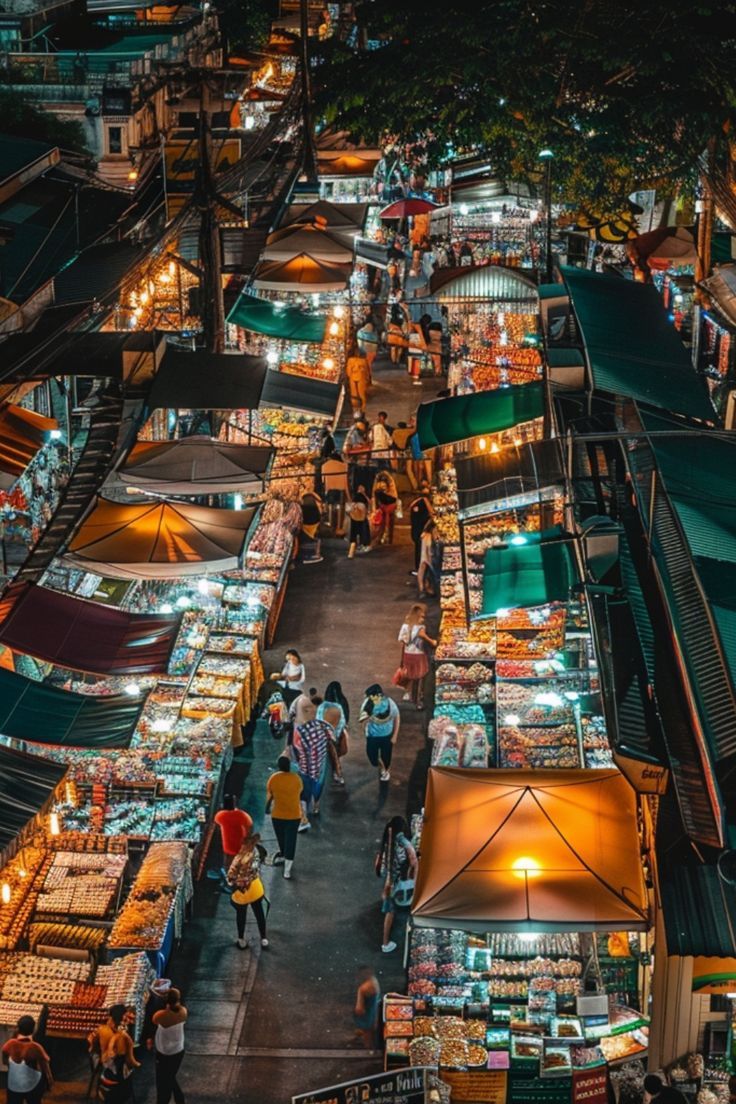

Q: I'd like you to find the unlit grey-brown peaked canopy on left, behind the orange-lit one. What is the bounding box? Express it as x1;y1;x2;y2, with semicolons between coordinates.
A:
118;436;275;495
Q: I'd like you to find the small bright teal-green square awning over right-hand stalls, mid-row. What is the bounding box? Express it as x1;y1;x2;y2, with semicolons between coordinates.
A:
481;527;576;617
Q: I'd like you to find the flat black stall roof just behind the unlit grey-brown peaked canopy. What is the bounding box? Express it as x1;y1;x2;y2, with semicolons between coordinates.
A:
148;346;267;410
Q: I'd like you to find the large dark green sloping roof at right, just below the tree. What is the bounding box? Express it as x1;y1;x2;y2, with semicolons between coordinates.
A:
563;266;716;422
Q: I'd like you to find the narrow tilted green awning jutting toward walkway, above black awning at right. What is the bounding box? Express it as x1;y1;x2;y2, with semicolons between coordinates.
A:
417;380;544;448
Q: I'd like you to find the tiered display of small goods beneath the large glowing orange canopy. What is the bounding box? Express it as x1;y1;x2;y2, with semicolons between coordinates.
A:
384;928;648;1081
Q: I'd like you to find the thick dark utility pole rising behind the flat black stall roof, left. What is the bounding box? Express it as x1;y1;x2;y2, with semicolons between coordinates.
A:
194;93;225;352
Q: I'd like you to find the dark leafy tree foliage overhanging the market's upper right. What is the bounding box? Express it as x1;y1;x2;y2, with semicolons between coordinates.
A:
318;0;736;214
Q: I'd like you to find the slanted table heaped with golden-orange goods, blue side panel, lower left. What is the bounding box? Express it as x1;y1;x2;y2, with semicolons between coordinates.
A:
107;842;193;976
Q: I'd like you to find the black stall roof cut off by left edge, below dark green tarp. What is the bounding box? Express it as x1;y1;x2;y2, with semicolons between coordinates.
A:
0;746;67;851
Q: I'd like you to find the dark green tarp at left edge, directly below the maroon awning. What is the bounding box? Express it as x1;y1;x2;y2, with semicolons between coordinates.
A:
0;668;143;747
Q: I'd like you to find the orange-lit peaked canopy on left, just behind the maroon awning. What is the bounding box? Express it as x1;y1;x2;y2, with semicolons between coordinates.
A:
64;498;256;578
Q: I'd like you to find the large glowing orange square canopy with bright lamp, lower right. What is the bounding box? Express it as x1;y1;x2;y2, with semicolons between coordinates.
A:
412;767;649;933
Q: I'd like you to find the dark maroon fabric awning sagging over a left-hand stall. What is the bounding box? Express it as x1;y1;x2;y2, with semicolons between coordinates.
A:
0;586;181;675
